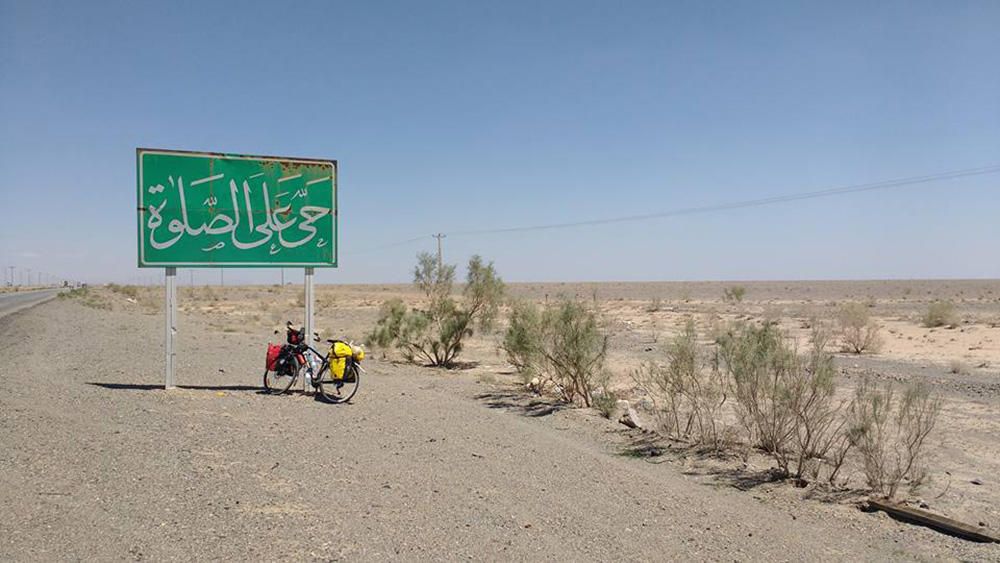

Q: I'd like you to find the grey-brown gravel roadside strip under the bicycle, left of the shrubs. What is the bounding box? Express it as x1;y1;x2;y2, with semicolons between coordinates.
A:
0;300;1000;561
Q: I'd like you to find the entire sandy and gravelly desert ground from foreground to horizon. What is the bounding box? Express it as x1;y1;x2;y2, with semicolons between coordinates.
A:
0;280;1000;561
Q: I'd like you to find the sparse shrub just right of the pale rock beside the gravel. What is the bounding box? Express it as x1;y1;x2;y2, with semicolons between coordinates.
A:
632;319;728;448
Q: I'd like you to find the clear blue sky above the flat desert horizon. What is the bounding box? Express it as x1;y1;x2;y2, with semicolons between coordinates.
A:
0;0;1000;283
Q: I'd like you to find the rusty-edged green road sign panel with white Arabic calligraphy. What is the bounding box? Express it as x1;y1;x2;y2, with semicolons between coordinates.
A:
136;149;337;268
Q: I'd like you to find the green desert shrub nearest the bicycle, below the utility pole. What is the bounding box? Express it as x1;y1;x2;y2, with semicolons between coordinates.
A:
369;252;504;367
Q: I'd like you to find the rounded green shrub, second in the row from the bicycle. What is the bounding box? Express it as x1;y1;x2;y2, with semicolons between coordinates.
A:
501;299;608;407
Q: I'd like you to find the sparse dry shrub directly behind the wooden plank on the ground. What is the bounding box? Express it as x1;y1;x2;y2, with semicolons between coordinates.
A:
850;379;941;499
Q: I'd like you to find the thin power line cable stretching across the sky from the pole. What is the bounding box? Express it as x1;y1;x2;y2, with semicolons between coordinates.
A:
373;164;1000;250
